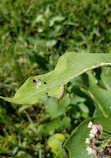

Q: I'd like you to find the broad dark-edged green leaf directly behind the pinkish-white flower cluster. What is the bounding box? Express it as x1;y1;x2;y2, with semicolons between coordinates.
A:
64;117;111;158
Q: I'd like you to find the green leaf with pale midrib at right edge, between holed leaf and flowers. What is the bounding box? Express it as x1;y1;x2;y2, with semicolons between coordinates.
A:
88;73;111;117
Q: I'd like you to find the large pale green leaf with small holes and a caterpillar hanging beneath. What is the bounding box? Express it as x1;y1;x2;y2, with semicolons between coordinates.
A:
0;52;111;104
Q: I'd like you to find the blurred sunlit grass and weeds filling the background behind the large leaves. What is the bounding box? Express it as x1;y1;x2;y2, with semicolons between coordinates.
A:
0;0;111;158
